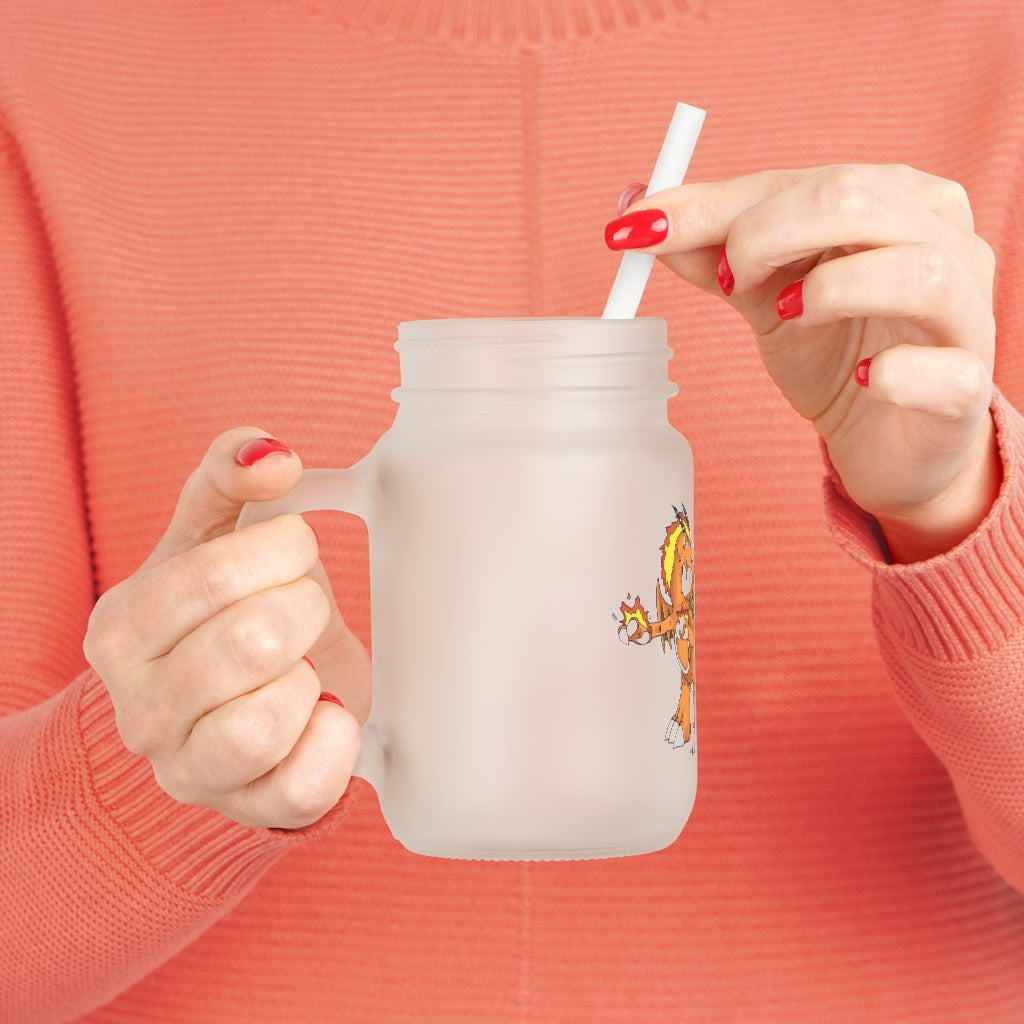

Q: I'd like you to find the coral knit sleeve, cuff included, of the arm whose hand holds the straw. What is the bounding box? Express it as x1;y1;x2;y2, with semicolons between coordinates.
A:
825;394;1024;892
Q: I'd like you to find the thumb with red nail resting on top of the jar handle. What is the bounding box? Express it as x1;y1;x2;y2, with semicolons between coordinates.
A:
145;427;302;565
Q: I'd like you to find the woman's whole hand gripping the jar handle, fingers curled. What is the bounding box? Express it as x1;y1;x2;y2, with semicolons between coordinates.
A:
85;428;370;828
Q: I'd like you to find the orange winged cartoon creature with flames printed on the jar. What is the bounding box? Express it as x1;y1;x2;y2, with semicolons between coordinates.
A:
617;506;693;746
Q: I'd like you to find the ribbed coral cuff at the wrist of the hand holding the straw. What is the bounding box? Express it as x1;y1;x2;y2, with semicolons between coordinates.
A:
825;392;1024;660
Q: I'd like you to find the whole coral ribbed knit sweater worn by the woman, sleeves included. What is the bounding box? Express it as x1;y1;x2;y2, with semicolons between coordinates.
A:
0;0;1024;1024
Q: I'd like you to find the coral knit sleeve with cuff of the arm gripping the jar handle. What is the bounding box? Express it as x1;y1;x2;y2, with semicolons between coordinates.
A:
0;123;344;1024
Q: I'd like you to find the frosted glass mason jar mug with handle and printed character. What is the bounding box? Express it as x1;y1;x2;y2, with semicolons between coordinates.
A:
240;318;696;860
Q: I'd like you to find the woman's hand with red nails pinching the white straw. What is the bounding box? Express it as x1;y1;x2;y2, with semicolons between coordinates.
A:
606;166;1001;562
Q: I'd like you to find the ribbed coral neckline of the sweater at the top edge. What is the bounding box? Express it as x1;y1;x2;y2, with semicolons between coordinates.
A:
324;0;708;46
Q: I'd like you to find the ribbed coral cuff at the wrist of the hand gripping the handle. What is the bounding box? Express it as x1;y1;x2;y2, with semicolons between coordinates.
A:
79;672;351;902
